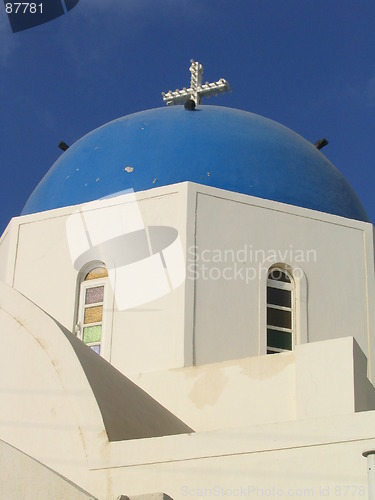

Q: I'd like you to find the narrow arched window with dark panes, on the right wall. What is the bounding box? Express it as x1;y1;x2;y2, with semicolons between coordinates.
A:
267;266;295;354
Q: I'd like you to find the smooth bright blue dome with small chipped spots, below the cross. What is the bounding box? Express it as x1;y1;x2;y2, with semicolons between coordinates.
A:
22;106;368;221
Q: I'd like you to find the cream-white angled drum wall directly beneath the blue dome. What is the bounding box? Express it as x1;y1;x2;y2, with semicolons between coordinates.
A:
0;183;375;380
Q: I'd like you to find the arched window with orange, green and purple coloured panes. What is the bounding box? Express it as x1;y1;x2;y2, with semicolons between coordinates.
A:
76;265;108;354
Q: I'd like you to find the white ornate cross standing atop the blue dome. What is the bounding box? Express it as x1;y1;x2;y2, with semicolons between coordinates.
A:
161;59;230;106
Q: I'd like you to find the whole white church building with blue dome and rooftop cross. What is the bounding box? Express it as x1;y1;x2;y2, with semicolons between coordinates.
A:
0;62;375;500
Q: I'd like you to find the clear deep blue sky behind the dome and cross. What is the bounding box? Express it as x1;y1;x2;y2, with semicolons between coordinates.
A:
0;0;375;234
